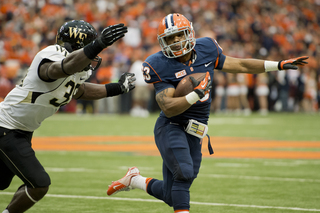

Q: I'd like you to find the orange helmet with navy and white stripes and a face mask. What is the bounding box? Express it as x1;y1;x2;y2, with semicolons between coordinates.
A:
158;13;196;58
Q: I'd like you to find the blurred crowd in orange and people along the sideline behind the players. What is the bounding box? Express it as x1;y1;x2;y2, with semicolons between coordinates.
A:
0;0;320;117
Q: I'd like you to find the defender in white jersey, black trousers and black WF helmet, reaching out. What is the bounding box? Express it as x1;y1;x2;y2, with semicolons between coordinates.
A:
0;20;135;213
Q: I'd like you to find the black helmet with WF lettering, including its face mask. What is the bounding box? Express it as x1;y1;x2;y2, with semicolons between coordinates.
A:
56;20;102;70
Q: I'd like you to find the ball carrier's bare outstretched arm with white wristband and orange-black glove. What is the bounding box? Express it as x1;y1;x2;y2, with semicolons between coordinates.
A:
222;56;309;74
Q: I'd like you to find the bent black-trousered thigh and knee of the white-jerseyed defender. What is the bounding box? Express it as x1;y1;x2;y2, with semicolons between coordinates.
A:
0;129;50;188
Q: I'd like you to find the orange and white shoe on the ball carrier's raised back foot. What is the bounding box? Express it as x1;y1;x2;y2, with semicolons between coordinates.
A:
107;167;140;195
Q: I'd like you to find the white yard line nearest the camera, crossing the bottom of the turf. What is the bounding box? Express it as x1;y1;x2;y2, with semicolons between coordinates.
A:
0;192;320;212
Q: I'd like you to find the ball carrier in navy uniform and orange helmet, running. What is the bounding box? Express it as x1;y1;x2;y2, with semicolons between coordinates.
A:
107;13;308;213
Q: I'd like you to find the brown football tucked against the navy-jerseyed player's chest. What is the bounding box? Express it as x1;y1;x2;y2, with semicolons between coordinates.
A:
173;73;206;97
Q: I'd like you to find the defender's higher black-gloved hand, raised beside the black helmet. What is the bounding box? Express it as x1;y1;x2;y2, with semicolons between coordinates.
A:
96;24;128;48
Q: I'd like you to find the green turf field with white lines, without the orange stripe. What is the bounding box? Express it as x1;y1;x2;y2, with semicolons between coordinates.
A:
0;114;320;213
